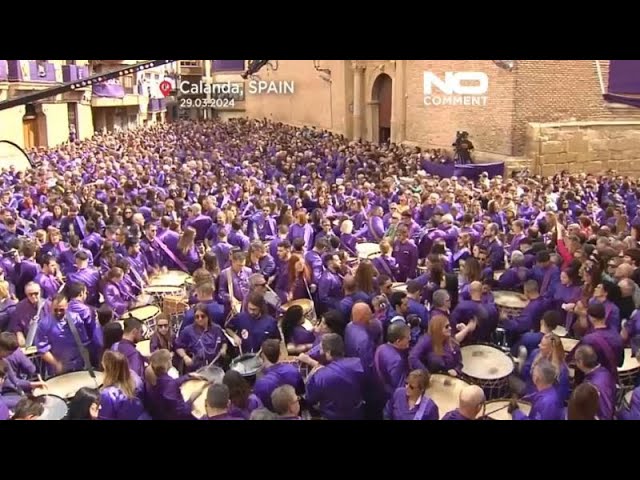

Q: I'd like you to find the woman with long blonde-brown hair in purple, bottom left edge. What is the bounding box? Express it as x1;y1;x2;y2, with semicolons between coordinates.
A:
98;350;150;420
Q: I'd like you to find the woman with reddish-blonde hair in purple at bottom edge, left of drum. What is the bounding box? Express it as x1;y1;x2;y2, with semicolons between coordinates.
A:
383;370;440;420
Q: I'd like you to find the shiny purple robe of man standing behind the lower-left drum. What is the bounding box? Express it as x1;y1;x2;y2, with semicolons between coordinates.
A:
34;312;90;373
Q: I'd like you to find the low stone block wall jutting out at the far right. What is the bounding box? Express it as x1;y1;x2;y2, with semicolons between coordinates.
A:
526;120;640;176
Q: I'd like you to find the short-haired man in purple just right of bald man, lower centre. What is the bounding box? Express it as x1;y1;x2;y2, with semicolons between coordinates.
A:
373;321;411;409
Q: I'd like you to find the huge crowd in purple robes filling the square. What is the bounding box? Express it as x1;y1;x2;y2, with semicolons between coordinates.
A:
0;119;640;420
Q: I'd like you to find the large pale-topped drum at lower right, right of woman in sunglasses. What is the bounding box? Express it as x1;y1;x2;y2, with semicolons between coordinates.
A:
460;345;514;399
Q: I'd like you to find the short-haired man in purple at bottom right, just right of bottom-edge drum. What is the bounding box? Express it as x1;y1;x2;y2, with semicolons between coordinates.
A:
508;360;564;420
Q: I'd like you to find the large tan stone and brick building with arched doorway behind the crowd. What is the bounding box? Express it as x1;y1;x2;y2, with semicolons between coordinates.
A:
228;60;640;174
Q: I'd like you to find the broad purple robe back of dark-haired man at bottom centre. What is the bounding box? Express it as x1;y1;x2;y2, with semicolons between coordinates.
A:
306;358;364;420
